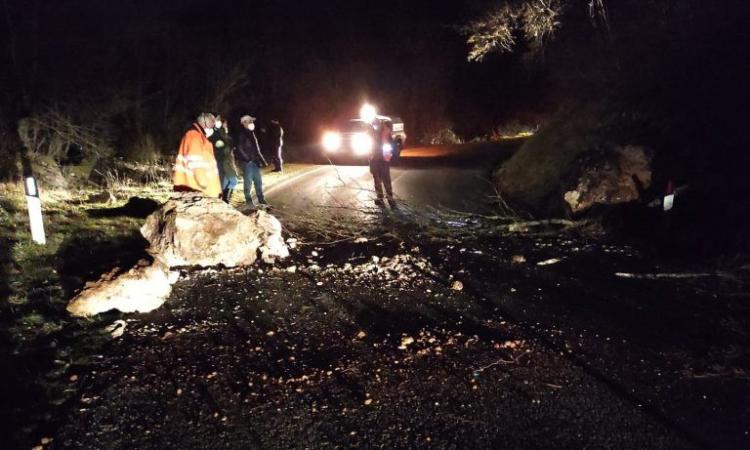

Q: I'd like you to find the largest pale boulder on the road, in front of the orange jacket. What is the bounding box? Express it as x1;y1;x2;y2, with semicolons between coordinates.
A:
141;194;289;267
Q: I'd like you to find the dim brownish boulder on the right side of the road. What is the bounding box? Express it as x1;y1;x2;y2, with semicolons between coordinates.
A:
563;145;652;214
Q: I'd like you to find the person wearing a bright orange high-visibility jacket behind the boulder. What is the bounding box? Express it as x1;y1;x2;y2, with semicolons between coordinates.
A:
172;113;221;198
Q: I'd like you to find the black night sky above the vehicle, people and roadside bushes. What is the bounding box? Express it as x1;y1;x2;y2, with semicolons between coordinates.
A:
0;0;750;163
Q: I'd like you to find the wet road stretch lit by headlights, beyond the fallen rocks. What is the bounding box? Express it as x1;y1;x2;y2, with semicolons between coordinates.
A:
266;141;520;216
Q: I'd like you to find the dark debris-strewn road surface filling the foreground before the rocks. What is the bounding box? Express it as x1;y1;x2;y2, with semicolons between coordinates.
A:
5;205;750;449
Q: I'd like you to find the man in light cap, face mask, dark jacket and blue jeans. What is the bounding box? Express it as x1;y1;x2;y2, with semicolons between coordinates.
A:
234;116;268;208
